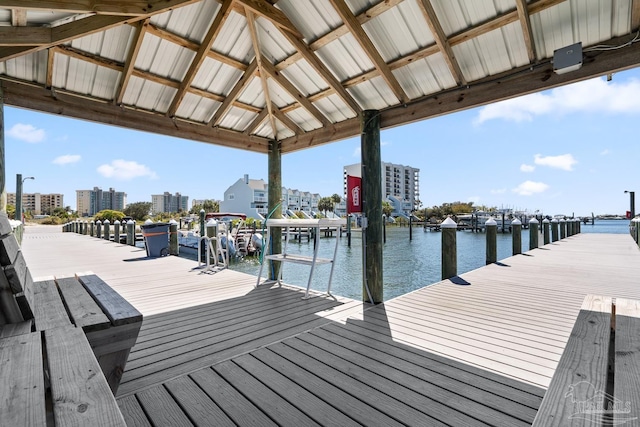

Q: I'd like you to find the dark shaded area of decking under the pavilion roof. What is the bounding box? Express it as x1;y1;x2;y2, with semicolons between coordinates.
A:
118;287;544;426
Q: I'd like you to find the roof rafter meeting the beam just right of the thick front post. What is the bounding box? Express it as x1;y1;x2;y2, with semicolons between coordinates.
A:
330;0;409;104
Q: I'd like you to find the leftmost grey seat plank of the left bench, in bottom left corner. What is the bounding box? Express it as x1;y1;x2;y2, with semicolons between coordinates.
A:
0;333;47;427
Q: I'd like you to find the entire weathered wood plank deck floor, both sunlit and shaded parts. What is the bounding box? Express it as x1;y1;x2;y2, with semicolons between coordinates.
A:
18;228;640;426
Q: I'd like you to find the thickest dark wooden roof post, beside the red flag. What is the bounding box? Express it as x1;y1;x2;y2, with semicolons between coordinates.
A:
360;110;384;304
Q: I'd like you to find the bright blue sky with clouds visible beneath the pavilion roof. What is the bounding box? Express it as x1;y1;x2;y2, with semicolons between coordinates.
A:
4;69;640;219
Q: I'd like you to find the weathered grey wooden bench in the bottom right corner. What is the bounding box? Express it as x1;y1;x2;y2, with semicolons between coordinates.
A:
533;295;640;427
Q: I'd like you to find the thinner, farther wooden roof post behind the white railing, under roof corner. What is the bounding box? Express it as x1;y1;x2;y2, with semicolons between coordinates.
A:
263;141;282;280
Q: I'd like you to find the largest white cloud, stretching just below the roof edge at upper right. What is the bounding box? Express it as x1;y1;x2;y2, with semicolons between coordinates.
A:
474;77;640;125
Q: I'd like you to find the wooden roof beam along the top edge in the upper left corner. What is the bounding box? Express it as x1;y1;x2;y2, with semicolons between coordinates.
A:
0;0;200;16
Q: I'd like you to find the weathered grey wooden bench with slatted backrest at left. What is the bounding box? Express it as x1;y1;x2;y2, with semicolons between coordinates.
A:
0;214;142;426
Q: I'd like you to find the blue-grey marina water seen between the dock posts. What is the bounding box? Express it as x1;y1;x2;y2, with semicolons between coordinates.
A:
184;220;629;300
